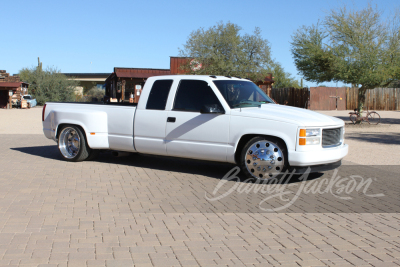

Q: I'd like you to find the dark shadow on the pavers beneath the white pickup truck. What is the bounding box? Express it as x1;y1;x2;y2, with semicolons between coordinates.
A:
10;145;324;184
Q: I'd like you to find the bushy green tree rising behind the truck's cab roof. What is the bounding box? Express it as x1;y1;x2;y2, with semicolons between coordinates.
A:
179;22;293;87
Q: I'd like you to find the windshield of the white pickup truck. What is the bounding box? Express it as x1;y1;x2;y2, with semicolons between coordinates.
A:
214;80;274;108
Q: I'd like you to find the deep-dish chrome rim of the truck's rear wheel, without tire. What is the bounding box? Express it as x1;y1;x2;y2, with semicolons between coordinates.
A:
58;127;81;159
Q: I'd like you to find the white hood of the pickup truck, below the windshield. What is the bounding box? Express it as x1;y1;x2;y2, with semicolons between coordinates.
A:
231;104;344;127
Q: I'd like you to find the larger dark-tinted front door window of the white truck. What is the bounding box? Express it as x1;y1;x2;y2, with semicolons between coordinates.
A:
173;80;224;112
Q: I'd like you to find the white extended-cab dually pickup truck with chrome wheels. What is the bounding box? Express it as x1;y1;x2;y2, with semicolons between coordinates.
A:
42;75;348;179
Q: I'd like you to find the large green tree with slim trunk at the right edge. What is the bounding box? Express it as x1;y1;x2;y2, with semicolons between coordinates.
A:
291;5;400;112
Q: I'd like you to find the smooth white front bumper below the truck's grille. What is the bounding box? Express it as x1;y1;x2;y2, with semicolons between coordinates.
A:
289;144;349;167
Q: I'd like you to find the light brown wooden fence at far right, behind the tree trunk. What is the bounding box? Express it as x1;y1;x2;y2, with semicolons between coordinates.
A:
346;88;400;110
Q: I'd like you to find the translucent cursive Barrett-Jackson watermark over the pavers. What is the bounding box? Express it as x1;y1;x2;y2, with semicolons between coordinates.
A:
205;167;385;212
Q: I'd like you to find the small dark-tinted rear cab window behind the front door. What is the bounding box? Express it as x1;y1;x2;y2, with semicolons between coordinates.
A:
146;80;173;110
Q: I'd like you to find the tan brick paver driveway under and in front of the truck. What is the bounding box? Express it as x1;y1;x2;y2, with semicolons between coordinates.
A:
0;110;400;266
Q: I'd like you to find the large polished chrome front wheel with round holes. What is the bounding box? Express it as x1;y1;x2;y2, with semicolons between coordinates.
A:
245;140;285;179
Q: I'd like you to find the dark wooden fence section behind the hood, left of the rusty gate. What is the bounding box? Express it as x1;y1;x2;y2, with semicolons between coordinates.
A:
268;88;309;108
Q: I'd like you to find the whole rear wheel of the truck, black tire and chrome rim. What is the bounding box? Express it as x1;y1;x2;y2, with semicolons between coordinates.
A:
57;125;92;162
